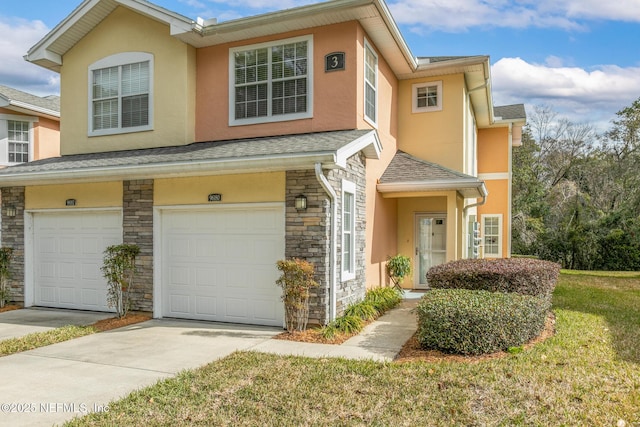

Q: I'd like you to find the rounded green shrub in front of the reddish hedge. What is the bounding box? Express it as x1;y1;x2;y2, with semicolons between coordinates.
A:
416;289;550;355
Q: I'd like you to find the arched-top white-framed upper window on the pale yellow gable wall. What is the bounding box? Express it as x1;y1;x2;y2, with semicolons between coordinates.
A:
89;52;153;136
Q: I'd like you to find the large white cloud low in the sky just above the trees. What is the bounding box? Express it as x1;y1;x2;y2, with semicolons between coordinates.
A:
491;57;640;130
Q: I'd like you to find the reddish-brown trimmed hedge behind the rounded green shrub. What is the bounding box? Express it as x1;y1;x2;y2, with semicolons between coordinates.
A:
427;258;560;298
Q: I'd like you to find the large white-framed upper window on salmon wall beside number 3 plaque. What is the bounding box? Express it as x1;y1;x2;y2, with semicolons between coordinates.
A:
229;36;313;126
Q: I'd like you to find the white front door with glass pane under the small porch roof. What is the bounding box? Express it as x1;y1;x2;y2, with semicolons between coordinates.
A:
413;214;447;288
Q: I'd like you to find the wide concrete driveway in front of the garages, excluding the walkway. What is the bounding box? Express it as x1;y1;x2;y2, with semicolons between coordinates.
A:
0;310;282;426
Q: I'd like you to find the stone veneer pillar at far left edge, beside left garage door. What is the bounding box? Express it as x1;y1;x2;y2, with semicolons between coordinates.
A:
2;187;24;304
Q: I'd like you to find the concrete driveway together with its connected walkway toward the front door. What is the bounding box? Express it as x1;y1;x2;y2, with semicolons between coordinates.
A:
0;294;416;426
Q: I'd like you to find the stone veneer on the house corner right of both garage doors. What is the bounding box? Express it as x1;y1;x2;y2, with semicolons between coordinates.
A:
285;153;366;324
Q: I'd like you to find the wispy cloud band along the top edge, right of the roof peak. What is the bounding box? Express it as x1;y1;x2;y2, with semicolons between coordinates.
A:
389;0;640;32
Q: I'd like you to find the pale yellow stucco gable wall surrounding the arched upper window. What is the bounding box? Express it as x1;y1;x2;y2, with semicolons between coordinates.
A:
60;7;196;155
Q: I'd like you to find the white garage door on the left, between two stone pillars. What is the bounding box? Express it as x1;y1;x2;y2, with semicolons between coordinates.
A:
33;211;122;311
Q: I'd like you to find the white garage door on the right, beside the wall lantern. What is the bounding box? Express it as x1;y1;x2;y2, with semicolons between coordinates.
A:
162;205;284;326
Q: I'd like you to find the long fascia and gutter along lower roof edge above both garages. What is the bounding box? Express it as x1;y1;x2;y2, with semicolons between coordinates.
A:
0;152;335;187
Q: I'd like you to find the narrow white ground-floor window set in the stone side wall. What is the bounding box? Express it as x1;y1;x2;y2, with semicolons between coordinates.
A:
342;180;356;281
